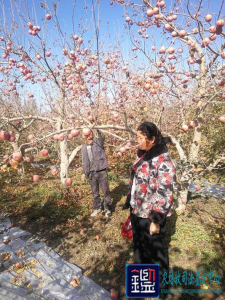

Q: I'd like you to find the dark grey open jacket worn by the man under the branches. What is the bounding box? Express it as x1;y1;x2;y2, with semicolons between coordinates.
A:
81;138;108;176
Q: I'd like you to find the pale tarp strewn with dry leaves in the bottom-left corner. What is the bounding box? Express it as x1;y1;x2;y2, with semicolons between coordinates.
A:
0;218;111;300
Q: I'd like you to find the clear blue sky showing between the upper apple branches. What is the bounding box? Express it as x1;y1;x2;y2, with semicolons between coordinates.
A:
0;0;225;108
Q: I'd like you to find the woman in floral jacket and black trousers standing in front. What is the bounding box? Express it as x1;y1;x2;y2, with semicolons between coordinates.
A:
123;122;175;296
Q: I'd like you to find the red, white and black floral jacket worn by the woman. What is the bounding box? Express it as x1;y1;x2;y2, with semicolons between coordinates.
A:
124;145;175;224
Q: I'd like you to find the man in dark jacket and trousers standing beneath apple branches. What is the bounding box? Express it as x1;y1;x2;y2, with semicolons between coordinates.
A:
81;127;111;217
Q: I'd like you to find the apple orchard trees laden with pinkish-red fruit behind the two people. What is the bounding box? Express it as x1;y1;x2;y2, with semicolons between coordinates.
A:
0;0;225;208
